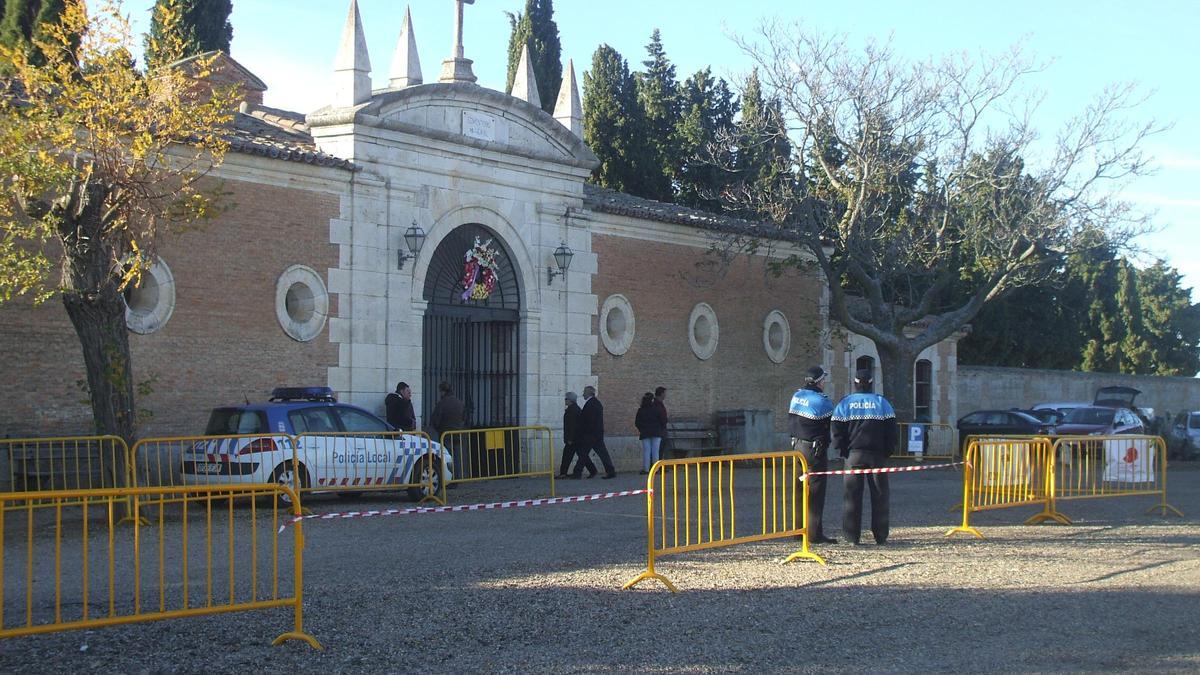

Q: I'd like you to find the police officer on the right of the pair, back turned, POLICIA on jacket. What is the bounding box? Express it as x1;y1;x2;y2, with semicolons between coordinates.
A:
833;370;896;545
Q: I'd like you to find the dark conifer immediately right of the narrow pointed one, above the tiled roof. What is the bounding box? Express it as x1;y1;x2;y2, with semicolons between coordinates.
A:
676;68;738;213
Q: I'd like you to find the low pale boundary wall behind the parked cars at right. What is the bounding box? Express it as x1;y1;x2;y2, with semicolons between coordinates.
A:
958;364;1200;417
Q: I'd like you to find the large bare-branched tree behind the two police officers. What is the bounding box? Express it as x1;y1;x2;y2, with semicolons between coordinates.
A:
725;23;1159;417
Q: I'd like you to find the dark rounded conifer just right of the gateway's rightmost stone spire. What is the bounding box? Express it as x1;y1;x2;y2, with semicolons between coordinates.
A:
583;44;652;197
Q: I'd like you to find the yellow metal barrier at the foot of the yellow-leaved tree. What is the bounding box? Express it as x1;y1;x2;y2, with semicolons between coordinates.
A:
0;436;128;508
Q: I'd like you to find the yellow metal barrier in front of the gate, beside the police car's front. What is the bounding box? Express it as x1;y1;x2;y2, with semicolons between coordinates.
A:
440;426;558;503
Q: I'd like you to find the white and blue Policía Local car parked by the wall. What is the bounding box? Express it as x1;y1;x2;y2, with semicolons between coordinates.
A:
180;387;454;501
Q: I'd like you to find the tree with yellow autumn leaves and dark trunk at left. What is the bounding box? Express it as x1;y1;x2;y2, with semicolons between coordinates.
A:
0;0;236;440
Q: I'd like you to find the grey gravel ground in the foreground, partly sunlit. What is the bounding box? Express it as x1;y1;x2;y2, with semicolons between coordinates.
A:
0;465;1200;673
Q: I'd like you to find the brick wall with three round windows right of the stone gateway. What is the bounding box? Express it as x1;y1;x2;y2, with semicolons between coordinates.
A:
592;234;822;436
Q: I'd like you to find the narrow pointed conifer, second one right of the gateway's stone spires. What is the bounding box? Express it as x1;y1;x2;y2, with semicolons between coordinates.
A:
634;29;680;202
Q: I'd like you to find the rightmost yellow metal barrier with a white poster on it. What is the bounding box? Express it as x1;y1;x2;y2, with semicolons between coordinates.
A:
1048;436;1183;522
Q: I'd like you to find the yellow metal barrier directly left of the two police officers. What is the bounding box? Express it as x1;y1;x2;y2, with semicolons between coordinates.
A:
624;452;826;592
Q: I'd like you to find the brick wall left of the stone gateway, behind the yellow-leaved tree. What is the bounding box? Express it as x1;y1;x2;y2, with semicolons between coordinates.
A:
0;171;340;436
